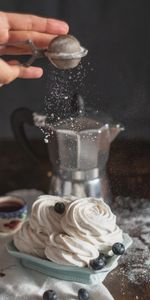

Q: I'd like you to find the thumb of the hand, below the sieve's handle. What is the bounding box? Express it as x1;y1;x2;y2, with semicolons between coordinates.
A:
0;59;43;84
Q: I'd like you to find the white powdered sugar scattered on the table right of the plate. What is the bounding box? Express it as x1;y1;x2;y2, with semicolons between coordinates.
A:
113;197;150;286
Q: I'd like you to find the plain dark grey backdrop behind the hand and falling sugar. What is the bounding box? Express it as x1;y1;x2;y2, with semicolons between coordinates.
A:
0;0;150;139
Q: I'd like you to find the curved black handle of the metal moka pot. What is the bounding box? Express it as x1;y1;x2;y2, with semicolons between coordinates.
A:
11;107;39;163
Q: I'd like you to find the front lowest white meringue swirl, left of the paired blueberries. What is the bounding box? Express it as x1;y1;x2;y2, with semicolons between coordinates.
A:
45;233;99;267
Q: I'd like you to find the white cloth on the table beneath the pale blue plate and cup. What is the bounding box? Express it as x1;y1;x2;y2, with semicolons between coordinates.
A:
0;190;113;300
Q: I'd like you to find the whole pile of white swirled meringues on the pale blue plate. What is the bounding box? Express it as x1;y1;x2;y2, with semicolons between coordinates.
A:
14;195;125;270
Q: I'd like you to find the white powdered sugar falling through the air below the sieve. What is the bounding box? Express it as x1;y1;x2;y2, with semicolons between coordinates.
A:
39;62;93;142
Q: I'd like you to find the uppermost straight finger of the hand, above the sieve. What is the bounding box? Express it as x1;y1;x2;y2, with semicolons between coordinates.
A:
6;13;69;35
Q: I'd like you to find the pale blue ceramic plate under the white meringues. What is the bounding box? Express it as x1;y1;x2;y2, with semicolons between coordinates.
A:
7;234;132;284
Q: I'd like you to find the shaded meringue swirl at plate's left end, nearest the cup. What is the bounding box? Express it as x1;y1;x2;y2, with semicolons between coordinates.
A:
14;221;47;258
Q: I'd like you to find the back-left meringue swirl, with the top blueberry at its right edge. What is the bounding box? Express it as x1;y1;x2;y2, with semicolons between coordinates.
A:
29;195;76;234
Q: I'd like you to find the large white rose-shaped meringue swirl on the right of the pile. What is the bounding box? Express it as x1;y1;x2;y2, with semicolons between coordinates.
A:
61;198;122;252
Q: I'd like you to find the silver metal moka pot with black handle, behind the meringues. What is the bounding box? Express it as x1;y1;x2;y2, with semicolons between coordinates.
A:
11;95;124;203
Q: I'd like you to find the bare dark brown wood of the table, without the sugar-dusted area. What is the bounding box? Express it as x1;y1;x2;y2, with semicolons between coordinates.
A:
0;141;150;300
